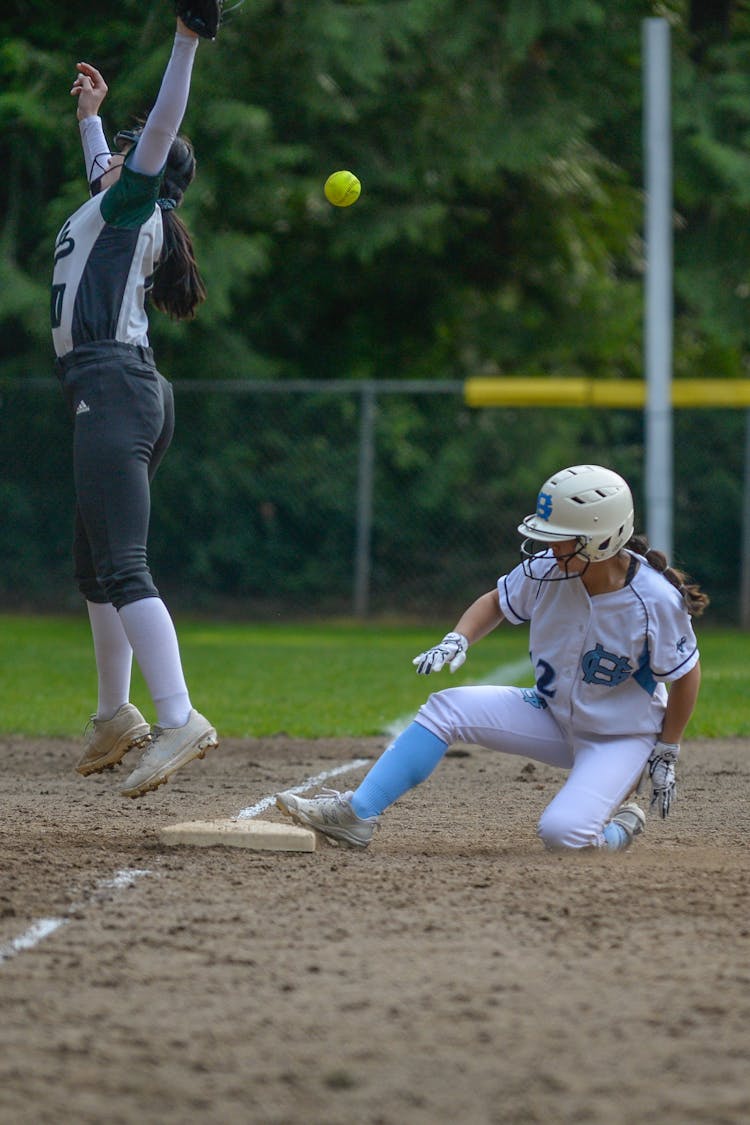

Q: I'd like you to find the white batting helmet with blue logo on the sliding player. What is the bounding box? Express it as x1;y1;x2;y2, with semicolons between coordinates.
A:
518;465;633;563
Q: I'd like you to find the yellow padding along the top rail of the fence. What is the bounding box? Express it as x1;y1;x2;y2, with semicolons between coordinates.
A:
463;376;750;410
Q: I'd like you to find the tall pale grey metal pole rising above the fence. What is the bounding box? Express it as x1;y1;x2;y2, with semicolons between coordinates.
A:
643;19;674;558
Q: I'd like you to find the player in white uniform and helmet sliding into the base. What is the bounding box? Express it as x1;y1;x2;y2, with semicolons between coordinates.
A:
277;465;708;851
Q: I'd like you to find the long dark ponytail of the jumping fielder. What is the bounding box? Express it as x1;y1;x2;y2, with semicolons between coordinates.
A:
150;136;206;321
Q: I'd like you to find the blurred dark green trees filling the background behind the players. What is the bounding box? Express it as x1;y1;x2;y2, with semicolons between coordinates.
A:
0;0;750;619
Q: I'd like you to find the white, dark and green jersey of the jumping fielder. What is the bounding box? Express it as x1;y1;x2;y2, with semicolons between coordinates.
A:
52;164;164;356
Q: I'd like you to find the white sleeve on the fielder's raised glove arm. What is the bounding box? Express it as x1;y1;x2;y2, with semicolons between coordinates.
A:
127;32;198;176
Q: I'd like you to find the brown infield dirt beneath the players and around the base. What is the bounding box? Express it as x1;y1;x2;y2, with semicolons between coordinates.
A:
0;737;750;1125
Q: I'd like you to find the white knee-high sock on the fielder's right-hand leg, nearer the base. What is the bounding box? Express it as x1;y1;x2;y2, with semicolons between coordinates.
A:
119;597;190;727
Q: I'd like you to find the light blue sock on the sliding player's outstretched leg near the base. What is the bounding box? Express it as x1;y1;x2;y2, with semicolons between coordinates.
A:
352;722;448;817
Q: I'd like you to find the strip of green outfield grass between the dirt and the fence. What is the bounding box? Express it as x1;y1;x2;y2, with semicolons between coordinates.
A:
0;614;750;738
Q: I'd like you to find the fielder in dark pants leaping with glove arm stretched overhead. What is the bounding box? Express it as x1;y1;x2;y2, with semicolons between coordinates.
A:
51;0;222;798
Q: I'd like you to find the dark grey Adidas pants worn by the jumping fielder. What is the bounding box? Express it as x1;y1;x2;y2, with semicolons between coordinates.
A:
55;341;174;609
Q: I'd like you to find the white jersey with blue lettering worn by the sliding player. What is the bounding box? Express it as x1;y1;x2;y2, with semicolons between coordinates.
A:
497;551;699;736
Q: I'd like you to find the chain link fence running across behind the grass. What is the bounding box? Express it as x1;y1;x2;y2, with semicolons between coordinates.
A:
0;379;743;620
